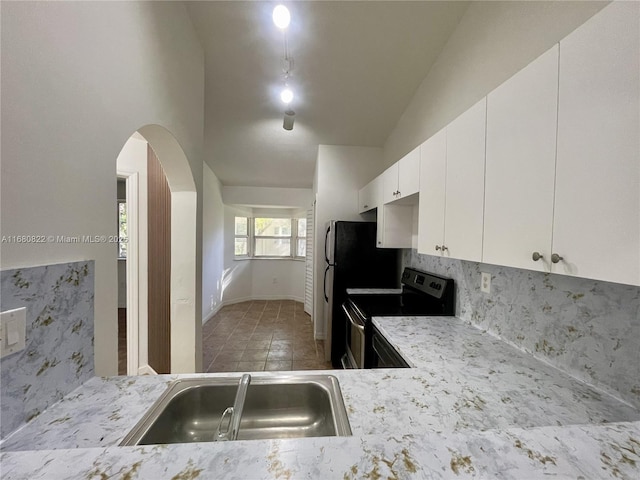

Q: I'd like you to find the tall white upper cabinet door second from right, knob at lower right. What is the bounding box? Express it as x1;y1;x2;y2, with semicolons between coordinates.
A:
482;45;558;271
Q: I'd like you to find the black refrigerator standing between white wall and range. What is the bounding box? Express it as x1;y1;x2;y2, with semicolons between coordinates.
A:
324;220;401;368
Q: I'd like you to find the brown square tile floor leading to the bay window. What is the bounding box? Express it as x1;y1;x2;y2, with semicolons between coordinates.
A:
202;300;332;372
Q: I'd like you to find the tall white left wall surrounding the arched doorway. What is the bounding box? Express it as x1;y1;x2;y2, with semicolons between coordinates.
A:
0;2;204;375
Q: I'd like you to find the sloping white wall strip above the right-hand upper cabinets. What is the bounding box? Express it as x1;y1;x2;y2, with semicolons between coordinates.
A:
384;1;608;167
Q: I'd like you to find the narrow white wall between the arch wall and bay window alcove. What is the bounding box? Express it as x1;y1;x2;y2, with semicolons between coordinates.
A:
202;164;225;323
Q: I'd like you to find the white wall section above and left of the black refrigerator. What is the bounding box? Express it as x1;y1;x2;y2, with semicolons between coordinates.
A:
313;145;383;338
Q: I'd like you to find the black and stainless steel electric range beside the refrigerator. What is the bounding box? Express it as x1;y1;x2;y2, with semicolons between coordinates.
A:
342;268;455;368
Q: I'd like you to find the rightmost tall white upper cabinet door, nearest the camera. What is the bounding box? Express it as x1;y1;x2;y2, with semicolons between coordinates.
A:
553;2;640;285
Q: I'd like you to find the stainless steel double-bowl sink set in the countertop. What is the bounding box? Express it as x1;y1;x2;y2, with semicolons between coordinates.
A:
120;375;351;446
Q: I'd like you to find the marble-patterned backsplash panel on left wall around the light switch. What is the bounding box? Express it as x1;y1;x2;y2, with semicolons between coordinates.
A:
0;261;94;439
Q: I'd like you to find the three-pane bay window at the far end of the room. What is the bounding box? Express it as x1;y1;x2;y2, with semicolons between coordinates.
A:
234;217;307;258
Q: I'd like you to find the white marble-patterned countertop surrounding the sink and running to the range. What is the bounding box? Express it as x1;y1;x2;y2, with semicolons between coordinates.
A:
0;317;640;479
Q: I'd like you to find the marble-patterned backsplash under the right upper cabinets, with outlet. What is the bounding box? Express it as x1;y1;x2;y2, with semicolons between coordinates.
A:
403;250;640;408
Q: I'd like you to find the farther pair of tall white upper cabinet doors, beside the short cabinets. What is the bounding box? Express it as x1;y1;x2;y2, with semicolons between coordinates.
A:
418;98;486;261
